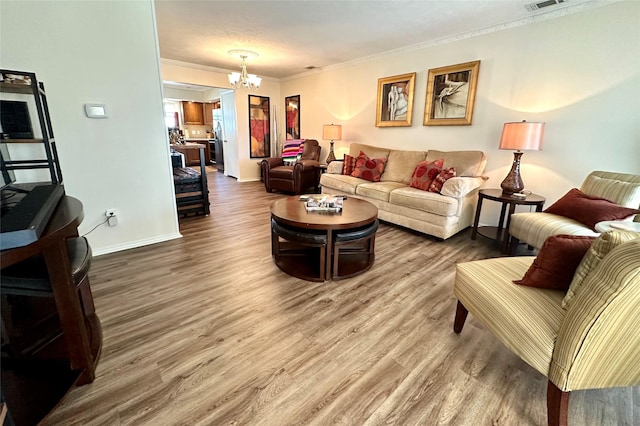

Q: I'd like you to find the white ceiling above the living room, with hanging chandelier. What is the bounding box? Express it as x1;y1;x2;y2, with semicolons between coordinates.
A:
155;0;604;78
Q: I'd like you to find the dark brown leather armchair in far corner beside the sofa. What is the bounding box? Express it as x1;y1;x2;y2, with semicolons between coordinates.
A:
260;139;321;194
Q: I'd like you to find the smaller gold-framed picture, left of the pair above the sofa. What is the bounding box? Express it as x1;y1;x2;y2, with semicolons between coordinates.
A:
376;72;416;127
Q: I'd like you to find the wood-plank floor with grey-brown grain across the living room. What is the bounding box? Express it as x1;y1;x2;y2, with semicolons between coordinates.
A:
45;171;640;426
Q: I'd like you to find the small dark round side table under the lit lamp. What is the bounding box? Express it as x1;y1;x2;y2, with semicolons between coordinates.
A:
471;189;546;253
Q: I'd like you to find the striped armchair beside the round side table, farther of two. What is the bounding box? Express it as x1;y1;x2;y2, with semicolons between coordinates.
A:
509;171;640;255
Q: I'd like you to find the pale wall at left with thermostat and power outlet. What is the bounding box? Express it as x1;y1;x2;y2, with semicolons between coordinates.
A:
0;0;180;254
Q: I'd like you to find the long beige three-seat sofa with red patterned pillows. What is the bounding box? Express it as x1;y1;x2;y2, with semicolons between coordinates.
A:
320;143;487;239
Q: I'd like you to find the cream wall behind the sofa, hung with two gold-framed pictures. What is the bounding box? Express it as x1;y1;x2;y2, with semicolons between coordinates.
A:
281;2;640;224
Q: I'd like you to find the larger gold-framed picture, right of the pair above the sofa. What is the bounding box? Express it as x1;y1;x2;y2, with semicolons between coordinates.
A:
424;61;480;126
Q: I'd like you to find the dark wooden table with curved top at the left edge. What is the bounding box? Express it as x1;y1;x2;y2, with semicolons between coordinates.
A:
0;196;102;425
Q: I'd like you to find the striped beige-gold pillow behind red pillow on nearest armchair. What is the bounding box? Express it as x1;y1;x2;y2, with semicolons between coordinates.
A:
562;230;640;309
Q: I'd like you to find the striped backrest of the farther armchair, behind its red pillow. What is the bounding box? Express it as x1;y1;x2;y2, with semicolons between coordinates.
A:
580;171;640;208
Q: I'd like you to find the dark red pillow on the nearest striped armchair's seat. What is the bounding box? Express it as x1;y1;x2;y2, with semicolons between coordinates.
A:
513;234;596;291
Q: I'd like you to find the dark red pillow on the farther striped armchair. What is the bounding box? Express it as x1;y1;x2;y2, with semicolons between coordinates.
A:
545;188;640;231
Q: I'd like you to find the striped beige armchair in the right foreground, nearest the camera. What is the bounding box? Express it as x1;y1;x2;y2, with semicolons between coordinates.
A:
454;236;640;426
